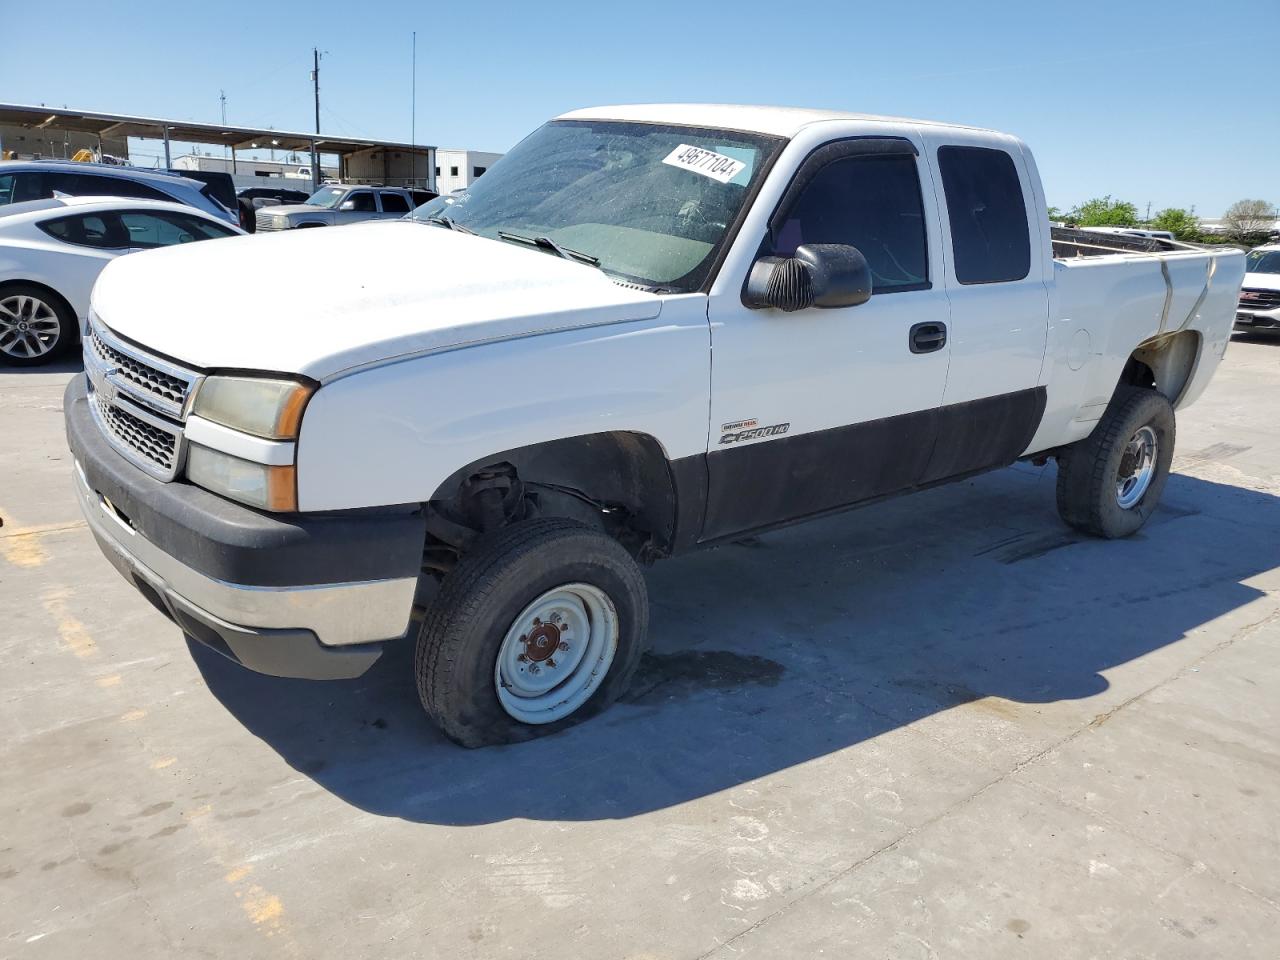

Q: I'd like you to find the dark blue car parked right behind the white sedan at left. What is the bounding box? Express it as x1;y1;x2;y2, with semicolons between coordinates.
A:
0;160;238;224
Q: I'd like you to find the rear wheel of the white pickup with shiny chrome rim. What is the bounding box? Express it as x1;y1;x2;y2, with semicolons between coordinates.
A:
1057;387;1175;539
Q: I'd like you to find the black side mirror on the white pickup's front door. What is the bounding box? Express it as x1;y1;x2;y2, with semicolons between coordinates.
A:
742;243;872;314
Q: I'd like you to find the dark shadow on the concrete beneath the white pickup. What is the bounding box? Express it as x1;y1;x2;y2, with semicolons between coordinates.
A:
192;466;1280;824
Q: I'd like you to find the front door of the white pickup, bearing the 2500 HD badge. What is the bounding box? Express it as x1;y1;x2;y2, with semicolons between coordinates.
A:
701;128;950;540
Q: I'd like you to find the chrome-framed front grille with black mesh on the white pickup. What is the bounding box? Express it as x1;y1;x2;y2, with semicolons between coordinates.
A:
84;314;204;480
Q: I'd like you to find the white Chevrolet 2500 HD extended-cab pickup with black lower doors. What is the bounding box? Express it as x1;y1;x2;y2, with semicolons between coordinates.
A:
65;105;1244;746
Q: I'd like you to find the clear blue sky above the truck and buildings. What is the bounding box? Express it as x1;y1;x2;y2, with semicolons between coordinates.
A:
0;0;1280;216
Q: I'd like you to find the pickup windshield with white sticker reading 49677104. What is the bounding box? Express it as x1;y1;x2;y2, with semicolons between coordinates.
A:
414;120;783;291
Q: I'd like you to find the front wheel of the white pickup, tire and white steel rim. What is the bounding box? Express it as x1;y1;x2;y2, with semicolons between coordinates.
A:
413;518;649;748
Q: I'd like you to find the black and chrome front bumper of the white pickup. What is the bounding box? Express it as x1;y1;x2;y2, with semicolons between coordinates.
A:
64;376;425;680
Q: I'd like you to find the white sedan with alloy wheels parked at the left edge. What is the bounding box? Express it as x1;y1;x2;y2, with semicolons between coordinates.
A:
0;196;244;365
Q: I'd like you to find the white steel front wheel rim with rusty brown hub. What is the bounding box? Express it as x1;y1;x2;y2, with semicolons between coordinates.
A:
493;584;618;723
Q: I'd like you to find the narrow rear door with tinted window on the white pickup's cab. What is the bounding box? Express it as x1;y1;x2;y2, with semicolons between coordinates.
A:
924;129;1051;481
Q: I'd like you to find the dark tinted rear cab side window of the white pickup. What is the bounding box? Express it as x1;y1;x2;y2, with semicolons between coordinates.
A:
938;146;1032;284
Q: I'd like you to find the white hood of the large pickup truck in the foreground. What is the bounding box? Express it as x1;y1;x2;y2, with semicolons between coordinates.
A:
93;220;662;380
